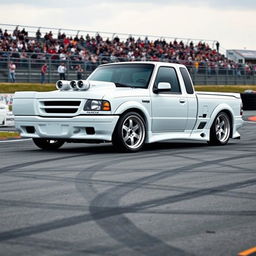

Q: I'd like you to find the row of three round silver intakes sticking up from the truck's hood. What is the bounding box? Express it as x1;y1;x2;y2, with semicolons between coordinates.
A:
56;80;90;91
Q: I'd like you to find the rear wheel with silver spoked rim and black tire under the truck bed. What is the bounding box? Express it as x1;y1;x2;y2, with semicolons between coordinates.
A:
208;112;231;146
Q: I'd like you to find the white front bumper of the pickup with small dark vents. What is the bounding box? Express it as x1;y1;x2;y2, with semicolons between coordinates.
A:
14;115;119;141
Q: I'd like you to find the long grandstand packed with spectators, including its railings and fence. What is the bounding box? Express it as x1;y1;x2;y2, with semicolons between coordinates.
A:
0;24;256;84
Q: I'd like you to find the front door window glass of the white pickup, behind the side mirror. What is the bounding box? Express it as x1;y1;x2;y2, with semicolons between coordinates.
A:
154;67;181;93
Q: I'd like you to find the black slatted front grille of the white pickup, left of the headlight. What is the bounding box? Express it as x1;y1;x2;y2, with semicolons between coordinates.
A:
39;100;81;116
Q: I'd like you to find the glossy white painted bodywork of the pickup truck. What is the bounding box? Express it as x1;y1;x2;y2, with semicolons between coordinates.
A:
14;62;243;143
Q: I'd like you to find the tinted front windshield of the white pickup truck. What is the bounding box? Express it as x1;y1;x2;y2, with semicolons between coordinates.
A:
88;64;154;88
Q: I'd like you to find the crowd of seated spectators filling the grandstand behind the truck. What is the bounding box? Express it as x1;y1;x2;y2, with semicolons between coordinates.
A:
0;26;256;75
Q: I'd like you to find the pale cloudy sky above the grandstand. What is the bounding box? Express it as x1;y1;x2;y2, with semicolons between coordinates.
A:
0;0;256;51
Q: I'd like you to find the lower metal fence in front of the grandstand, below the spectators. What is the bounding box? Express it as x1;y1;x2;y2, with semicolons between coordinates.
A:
0;52;256;85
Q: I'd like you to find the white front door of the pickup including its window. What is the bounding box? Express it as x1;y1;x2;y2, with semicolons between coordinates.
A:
151;66;188;133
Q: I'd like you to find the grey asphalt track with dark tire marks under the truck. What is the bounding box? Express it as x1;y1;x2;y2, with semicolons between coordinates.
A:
0;122;256;256
